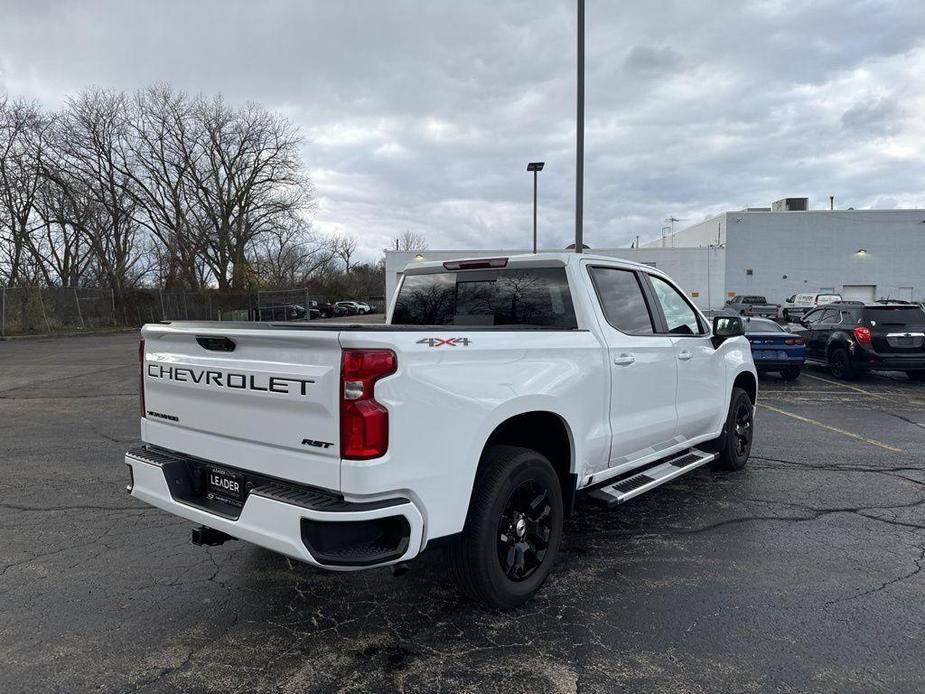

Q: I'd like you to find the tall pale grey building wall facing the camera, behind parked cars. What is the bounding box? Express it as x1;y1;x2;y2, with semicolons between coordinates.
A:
725;210;925;303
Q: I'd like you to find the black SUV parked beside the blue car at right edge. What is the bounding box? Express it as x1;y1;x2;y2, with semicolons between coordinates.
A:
792;302;925;381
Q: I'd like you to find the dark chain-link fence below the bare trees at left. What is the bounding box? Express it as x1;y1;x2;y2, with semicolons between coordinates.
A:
0;287;383;337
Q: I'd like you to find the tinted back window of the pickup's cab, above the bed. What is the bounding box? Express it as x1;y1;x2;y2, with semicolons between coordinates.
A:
392;268;577;329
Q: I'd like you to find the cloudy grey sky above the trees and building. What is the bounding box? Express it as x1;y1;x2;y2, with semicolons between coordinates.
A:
0;0;925;259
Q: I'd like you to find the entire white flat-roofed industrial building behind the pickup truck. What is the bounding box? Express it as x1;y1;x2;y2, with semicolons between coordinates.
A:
385;198;925;309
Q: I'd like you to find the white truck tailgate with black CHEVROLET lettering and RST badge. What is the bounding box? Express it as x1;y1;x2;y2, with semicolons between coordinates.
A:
142;323;341;490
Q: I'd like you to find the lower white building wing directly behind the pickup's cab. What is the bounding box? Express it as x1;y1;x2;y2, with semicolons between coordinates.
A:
385;248;726;310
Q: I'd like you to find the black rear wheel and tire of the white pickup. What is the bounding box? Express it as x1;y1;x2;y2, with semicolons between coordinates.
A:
447;446;563;609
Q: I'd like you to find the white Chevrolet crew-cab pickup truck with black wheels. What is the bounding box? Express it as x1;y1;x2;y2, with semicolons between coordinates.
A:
125;253;758;608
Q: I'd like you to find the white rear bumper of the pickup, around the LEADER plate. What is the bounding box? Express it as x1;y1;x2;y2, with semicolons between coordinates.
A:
125;447;424;571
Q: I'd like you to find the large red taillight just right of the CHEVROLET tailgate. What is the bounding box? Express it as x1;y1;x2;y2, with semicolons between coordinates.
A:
340;349;398;460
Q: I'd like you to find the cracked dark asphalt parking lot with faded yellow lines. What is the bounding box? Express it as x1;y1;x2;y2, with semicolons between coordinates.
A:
0;334;925;692
